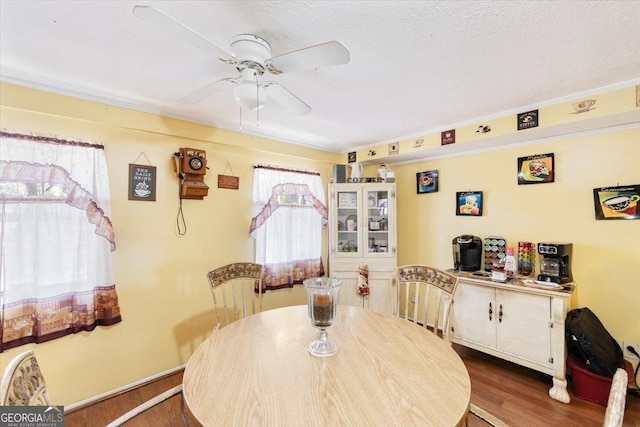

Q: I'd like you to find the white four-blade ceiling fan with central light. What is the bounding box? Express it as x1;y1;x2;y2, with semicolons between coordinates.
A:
133;6;350;115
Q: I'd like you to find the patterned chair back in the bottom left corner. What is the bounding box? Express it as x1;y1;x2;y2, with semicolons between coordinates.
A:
0;350;51;406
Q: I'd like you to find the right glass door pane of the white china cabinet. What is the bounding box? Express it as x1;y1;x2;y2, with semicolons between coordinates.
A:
365;190;390;253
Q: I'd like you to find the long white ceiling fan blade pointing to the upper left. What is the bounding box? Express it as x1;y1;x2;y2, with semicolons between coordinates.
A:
133;6;237;63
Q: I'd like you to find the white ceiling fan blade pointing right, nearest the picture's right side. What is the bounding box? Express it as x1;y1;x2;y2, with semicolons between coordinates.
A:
267;41;351;74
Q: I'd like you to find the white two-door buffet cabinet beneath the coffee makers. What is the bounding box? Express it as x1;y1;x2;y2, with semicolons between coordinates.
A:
451;273;573;403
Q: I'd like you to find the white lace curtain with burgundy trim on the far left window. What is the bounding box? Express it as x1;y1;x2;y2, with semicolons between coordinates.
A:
0;131;120;351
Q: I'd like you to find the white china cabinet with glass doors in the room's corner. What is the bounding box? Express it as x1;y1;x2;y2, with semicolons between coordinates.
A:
329;183;397;313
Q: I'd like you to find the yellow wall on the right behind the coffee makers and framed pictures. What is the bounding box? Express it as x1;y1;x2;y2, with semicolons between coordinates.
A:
393;128;640;352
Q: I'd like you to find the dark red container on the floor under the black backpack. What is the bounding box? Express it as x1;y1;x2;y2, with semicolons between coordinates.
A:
567;354;633;406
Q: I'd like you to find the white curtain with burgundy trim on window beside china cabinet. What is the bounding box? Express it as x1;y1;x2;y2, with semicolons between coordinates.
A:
250;166;328;290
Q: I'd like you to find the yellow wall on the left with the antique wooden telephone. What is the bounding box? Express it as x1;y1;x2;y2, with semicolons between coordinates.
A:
0;84;338;405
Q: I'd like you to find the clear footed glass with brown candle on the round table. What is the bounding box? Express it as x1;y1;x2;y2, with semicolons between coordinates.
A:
303;277;342;357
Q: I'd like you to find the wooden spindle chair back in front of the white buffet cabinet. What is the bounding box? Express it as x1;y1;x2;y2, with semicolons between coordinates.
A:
396;264;458;342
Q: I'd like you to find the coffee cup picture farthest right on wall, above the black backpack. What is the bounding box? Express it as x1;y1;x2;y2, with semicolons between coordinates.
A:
593;184;640;220
